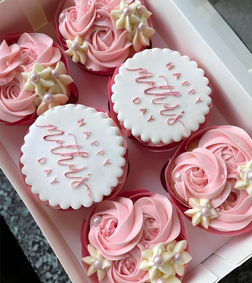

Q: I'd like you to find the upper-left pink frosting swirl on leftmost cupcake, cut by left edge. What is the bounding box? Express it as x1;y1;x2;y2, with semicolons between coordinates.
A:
0;40;23;86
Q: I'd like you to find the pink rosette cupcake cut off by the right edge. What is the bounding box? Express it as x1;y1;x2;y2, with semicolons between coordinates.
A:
165;126;252;236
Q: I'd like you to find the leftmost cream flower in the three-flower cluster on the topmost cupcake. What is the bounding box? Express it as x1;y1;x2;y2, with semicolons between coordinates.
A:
111;0;140;32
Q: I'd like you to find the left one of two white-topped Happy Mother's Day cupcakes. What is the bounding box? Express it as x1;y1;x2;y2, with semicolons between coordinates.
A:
20;104;127;209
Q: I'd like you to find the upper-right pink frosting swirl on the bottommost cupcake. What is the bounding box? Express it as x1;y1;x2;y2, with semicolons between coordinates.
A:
134;195;181;249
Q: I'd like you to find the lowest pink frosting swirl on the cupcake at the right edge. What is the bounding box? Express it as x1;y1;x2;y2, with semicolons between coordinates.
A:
210;189;252;232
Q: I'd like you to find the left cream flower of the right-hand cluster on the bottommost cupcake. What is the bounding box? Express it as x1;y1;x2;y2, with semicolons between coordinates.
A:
139;244;173;282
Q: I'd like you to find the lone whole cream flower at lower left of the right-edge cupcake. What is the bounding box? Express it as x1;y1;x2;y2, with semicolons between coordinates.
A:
184;198;218;229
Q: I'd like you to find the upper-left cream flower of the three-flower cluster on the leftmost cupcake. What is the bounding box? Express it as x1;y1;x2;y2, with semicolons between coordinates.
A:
22;63;55;96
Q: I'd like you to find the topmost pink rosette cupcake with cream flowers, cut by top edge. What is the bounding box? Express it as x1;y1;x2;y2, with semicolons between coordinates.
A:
54;0;154;75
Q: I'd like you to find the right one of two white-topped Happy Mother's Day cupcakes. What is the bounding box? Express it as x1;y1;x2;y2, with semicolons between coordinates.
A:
108;48;211;151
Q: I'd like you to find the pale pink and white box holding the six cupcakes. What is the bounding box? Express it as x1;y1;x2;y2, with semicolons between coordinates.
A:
0;0;252;283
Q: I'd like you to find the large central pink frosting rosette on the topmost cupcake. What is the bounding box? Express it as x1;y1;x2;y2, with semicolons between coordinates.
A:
84;9;132;71
